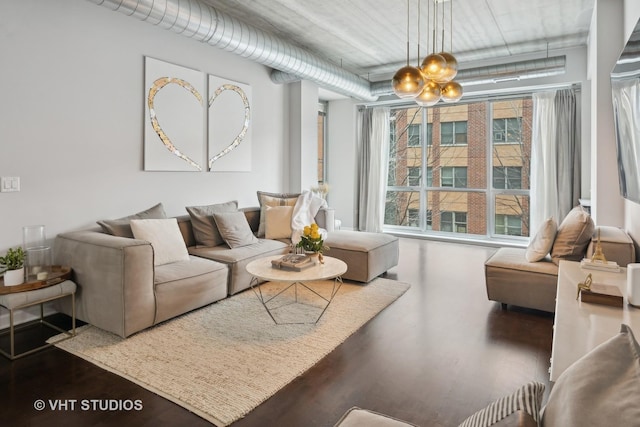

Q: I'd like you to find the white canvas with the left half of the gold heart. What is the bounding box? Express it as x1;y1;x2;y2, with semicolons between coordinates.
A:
144;57;206;171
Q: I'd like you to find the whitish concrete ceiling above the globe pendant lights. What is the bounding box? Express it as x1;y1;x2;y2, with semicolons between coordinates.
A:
204;0;594;81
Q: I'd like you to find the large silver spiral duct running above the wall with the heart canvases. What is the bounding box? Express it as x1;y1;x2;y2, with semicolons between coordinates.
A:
89;0;377;101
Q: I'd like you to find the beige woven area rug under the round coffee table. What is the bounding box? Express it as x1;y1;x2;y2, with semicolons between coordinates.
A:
51;278;409;426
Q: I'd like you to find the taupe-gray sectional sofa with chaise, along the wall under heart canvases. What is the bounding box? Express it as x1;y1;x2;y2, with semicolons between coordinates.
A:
54;205;398;337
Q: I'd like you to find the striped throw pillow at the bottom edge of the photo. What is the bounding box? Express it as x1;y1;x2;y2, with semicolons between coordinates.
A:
459;381;544;427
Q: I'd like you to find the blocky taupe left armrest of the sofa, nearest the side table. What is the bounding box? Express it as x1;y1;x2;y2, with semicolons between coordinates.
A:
54;230;156;337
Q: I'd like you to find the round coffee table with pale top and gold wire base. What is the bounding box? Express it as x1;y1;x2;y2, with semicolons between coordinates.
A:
246;255;347;325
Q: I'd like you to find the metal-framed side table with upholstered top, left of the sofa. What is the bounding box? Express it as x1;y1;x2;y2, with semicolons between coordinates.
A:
0;280;76;360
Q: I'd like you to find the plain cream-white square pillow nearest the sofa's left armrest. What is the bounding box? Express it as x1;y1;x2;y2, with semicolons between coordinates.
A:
131;218;189;265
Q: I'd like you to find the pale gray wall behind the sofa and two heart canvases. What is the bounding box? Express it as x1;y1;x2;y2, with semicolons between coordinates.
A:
0;0;290;253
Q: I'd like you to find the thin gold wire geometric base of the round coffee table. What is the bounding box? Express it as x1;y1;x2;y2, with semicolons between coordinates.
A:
251;276;342;325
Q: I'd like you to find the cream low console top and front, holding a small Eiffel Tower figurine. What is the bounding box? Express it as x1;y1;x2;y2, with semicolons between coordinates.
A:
550;261;640;381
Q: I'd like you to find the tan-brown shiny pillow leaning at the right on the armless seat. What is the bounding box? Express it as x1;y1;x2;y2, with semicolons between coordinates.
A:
551;206;595;264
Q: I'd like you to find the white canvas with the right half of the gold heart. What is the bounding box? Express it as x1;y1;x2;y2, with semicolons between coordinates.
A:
208;75;251;172
